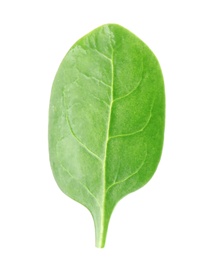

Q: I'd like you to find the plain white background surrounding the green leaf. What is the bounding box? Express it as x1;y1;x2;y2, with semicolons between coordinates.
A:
0;0;210;260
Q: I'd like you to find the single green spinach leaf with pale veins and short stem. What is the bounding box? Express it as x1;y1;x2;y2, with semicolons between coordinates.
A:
49;24;165;247
